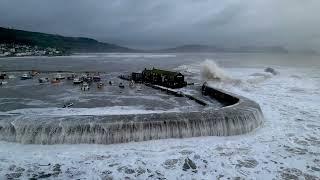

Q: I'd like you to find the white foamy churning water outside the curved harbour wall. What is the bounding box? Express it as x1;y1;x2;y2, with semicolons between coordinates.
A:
0;54;320;179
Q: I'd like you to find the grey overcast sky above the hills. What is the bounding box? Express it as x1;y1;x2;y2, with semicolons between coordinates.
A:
0;0;320;50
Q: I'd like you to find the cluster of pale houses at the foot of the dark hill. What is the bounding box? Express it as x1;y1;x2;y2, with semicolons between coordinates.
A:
0;43;63;57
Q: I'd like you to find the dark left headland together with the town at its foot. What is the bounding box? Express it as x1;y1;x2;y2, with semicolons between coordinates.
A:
0;27;137;56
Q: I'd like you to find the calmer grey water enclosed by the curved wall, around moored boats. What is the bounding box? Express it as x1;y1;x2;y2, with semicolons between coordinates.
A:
0;72;219;115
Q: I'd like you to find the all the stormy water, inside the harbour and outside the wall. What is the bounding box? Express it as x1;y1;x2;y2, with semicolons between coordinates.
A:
0;53;320;179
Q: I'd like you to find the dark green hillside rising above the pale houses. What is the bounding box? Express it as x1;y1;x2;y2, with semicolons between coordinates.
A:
0;27;134;53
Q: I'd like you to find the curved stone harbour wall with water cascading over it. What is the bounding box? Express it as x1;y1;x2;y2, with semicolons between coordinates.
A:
0;86;263;144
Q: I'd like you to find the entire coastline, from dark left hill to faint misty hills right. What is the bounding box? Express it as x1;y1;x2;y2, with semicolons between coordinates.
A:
0;27;318;54
